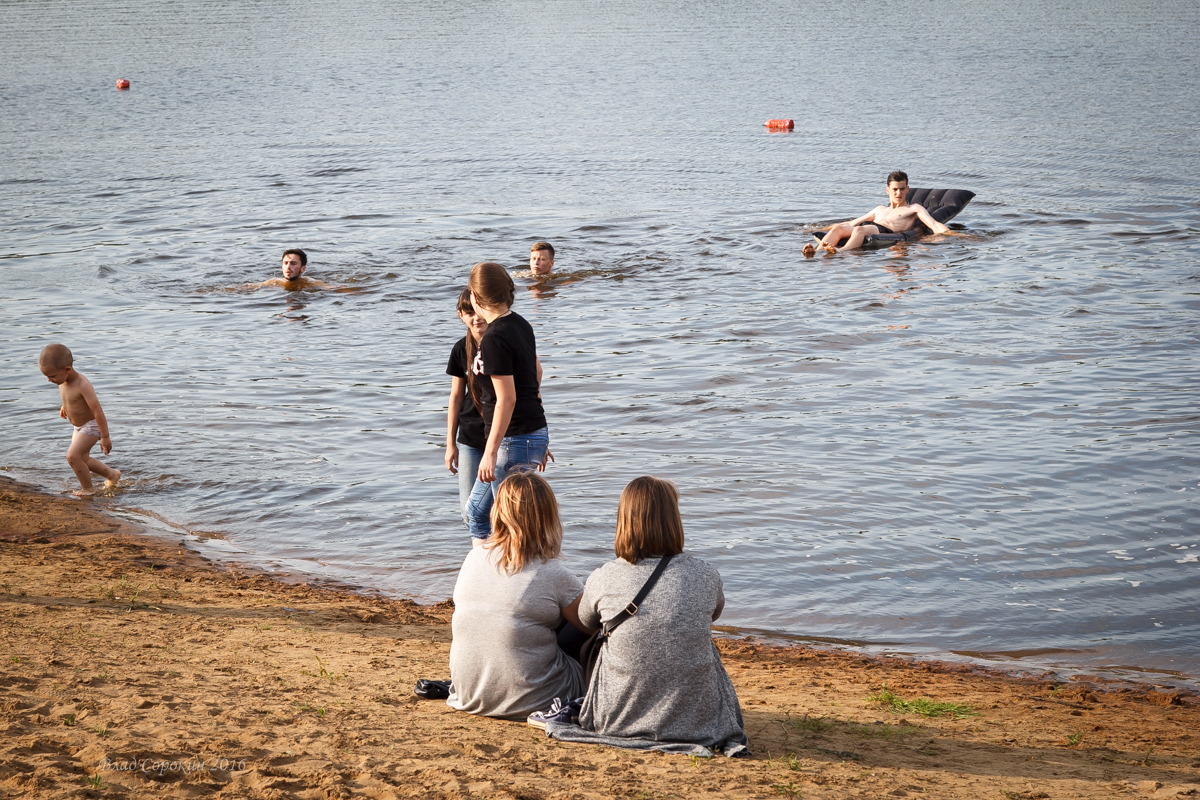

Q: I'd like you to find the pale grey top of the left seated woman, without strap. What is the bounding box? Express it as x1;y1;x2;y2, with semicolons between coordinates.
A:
446;547;583;720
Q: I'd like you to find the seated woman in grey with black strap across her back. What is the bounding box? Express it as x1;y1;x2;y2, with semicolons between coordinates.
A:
529;476;748;754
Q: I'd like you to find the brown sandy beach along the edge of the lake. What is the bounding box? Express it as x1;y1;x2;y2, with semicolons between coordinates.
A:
0;479;1200;800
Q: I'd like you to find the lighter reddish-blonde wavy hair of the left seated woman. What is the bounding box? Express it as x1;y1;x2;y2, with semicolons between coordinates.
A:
484;470;563;575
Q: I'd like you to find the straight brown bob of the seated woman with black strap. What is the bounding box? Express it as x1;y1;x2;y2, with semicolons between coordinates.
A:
613;475;683;564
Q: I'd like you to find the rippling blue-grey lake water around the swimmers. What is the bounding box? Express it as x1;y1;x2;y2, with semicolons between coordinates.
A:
0;0;1200;685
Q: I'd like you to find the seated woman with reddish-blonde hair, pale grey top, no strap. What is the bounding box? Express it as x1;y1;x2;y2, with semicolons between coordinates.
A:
446;473;583;720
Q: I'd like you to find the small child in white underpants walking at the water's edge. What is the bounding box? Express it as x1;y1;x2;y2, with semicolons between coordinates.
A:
37;344;121;498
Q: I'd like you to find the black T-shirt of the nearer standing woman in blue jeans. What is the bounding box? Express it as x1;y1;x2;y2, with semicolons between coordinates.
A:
472;312;546;437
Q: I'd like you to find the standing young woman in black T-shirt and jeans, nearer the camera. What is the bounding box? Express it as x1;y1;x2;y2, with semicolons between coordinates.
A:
467;261;550;545
